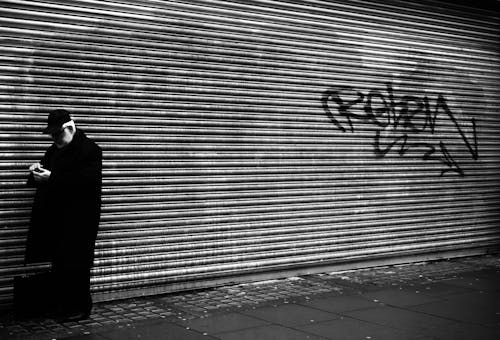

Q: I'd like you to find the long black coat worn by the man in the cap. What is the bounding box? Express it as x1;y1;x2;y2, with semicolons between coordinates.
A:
25;129;102;267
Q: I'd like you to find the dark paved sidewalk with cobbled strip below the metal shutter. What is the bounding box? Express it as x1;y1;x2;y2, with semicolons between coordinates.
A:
0;254;500;340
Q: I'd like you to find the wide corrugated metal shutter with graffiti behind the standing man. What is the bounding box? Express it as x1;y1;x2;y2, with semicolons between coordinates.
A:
0;0;500;302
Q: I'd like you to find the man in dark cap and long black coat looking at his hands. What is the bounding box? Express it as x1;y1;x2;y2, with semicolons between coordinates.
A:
25;110;102;321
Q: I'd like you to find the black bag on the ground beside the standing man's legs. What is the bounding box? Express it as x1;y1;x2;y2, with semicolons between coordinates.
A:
14;272;56;318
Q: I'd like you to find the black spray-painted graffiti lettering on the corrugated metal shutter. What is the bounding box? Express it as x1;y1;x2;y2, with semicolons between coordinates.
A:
321;83;479;176
